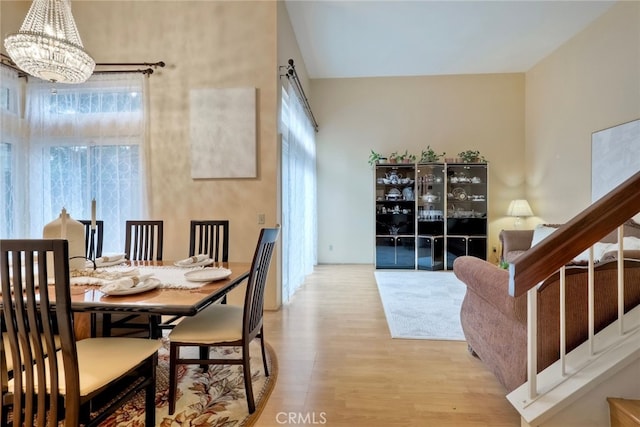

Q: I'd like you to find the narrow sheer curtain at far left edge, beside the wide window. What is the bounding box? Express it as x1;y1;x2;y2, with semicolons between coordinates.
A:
0;66;26;238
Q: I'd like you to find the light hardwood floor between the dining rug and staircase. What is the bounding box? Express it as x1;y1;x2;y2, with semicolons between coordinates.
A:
255;265;520;427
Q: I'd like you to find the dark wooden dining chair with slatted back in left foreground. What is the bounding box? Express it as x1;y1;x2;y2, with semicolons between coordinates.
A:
0;239;160;427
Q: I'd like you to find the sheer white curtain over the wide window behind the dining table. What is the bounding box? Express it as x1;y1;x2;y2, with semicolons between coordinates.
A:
26;74;147;252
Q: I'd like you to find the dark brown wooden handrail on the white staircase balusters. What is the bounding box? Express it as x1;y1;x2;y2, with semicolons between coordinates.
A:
509;171;640;297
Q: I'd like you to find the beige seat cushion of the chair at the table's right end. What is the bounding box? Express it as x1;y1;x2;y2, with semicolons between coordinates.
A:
169;304;243;344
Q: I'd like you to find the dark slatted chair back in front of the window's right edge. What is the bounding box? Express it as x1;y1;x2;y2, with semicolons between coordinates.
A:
124;220;164;261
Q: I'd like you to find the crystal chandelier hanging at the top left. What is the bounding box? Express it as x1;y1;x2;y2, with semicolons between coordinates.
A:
4;0;96;83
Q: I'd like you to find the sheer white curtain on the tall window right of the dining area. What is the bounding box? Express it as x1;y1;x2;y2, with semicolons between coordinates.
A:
281;85;318;303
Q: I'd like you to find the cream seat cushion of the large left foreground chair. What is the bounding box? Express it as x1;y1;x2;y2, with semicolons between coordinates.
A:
8;338;161;396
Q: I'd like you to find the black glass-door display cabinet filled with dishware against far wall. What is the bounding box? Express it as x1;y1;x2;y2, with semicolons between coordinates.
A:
374;163;488;270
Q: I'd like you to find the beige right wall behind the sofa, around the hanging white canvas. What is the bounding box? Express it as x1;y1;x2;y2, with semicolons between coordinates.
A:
526;2;640;225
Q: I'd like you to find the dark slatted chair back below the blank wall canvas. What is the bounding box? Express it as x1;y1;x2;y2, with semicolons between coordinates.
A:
189;220;229;262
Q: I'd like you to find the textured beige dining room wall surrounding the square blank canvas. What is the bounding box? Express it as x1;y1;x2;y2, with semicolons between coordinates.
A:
0;0;280;308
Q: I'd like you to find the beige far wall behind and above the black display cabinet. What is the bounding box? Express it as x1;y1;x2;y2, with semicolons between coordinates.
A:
311;74;525;263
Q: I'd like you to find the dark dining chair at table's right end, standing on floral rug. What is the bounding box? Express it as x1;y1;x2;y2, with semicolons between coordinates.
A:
169;227;280;414
